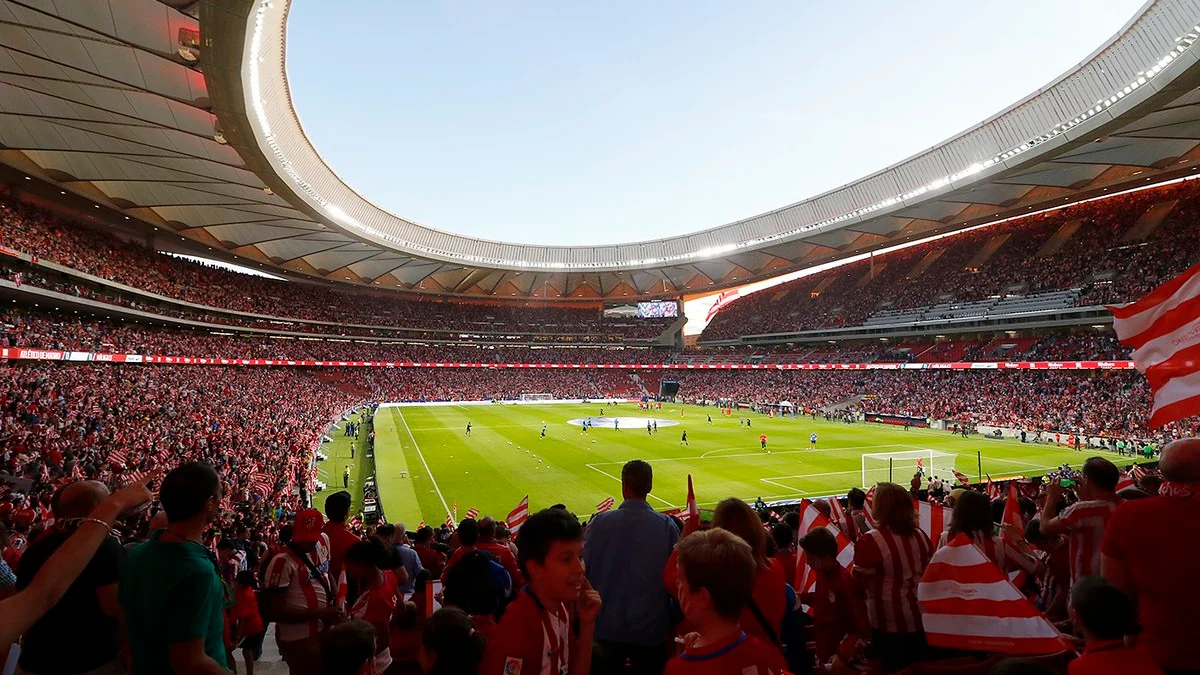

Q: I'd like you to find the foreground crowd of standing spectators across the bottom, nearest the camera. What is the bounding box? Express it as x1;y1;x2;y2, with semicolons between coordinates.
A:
0;438;1200;675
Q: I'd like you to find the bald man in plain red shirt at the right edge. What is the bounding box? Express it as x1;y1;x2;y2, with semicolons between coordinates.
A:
1100;438;1200;675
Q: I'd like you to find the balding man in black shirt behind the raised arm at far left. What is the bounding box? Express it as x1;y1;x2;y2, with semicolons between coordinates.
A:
17;480;125;675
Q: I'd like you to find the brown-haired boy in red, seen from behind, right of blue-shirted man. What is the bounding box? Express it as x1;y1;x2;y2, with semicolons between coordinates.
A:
664;528;787;675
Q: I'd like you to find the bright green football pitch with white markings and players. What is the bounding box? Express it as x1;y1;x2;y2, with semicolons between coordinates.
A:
352;404;1088;527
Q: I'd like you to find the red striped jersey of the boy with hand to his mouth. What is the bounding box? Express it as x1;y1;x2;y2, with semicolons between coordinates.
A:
479;586;571;675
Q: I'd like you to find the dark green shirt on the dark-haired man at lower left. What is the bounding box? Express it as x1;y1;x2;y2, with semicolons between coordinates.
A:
120;530;226;675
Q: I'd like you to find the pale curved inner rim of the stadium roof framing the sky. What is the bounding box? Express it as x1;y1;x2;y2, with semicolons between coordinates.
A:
231;0;1200;271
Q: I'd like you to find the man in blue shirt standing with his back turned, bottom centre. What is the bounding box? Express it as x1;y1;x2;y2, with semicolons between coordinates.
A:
583;460;679;675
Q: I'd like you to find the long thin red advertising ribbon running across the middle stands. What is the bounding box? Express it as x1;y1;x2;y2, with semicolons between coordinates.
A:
0;347;1134;369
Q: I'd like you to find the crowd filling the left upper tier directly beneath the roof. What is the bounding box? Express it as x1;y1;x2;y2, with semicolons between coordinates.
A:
0;197;674;339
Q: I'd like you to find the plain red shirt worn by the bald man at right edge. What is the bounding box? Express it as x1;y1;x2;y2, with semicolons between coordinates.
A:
1100;497;1200;670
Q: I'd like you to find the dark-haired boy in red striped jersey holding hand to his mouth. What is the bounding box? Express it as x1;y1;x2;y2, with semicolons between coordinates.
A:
479;508;600;675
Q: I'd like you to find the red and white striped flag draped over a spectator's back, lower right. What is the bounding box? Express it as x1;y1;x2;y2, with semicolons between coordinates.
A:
917;534;1068;655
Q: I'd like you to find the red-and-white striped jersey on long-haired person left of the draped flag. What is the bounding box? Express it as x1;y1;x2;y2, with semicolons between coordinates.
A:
854;527;934;633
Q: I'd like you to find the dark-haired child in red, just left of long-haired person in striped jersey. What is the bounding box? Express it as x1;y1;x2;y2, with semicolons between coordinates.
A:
800;527;871;665
